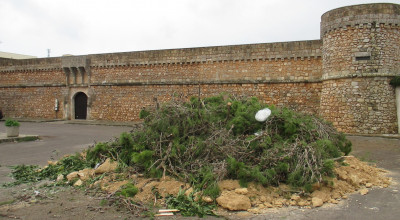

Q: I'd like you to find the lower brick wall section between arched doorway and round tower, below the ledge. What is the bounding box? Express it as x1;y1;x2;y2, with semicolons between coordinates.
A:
90;83;321;121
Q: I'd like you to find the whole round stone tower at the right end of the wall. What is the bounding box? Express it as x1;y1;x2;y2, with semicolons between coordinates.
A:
320;3;400;134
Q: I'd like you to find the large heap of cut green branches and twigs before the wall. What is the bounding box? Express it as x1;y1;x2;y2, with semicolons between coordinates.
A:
86;95;351;197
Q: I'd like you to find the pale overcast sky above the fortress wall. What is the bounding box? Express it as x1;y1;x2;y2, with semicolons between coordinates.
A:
0;0;400;57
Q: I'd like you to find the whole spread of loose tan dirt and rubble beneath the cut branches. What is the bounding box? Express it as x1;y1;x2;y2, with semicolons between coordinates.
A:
61;156;390;214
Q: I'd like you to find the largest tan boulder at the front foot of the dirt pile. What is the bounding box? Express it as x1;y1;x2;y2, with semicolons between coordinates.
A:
217;191;251;211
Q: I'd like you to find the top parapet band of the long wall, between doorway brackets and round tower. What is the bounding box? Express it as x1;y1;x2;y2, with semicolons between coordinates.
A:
89;40;322;67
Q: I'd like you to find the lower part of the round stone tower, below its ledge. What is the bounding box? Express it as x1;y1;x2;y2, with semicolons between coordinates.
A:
321;77;397;134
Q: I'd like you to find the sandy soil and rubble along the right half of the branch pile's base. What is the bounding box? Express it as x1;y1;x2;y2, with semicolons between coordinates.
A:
212;156;390;213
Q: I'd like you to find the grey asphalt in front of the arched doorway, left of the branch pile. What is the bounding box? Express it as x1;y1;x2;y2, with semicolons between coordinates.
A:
0;121;131;183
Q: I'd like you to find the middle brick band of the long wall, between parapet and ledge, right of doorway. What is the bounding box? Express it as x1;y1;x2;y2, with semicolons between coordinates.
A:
91;58;322;85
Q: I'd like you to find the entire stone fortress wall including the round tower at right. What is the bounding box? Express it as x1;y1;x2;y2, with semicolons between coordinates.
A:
0;4;400;134
